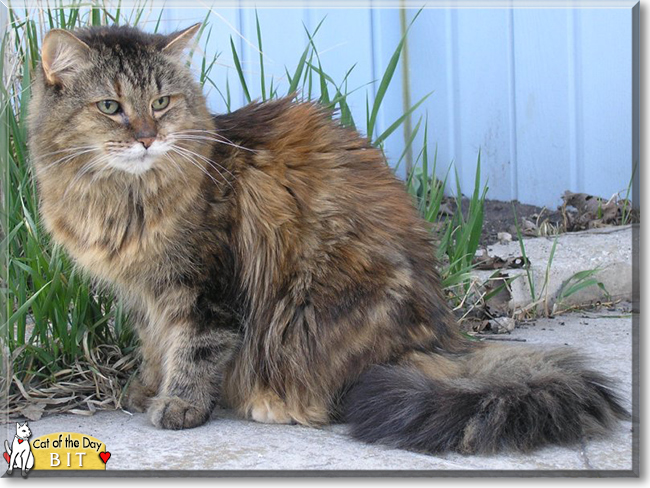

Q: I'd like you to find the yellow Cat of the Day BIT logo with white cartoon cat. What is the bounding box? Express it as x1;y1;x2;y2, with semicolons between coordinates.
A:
4;422;111;477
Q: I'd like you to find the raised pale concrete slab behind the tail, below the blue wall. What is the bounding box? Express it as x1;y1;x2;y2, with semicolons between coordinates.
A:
474;225;633;310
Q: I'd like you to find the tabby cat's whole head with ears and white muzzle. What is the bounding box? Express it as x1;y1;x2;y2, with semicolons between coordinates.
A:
30;26;207;175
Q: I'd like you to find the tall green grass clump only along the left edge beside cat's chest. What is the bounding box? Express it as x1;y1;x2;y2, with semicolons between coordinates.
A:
0;1;141;418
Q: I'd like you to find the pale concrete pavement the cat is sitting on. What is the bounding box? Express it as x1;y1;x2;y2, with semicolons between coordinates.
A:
5;312;638;476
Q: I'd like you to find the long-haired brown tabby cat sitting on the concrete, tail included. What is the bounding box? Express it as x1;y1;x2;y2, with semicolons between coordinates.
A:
29;26;626;452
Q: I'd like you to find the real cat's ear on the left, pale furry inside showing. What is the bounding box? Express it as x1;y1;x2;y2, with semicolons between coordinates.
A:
41;29;90;85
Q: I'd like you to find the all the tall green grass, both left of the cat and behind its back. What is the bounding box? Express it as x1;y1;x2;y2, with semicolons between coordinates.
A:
0;2;487;413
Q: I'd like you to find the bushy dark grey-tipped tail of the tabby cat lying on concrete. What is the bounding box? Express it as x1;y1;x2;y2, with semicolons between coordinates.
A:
345;345;630;453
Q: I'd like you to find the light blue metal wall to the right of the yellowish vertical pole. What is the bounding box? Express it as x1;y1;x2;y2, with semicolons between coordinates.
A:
410;8;638;207
